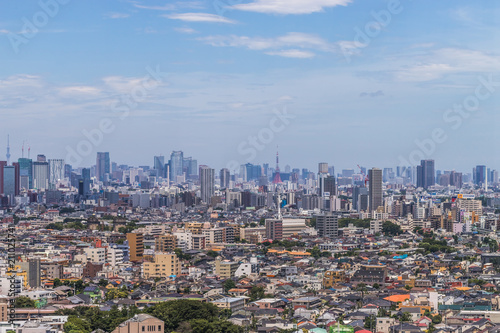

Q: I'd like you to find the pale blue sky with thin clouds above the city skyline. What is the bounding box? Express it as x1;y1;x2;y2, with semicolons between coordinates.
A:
0;0;500;172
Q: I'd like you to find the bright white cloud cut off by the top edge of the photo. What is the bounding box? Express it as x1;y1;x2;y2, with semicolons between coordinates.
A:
230;0;352;15
